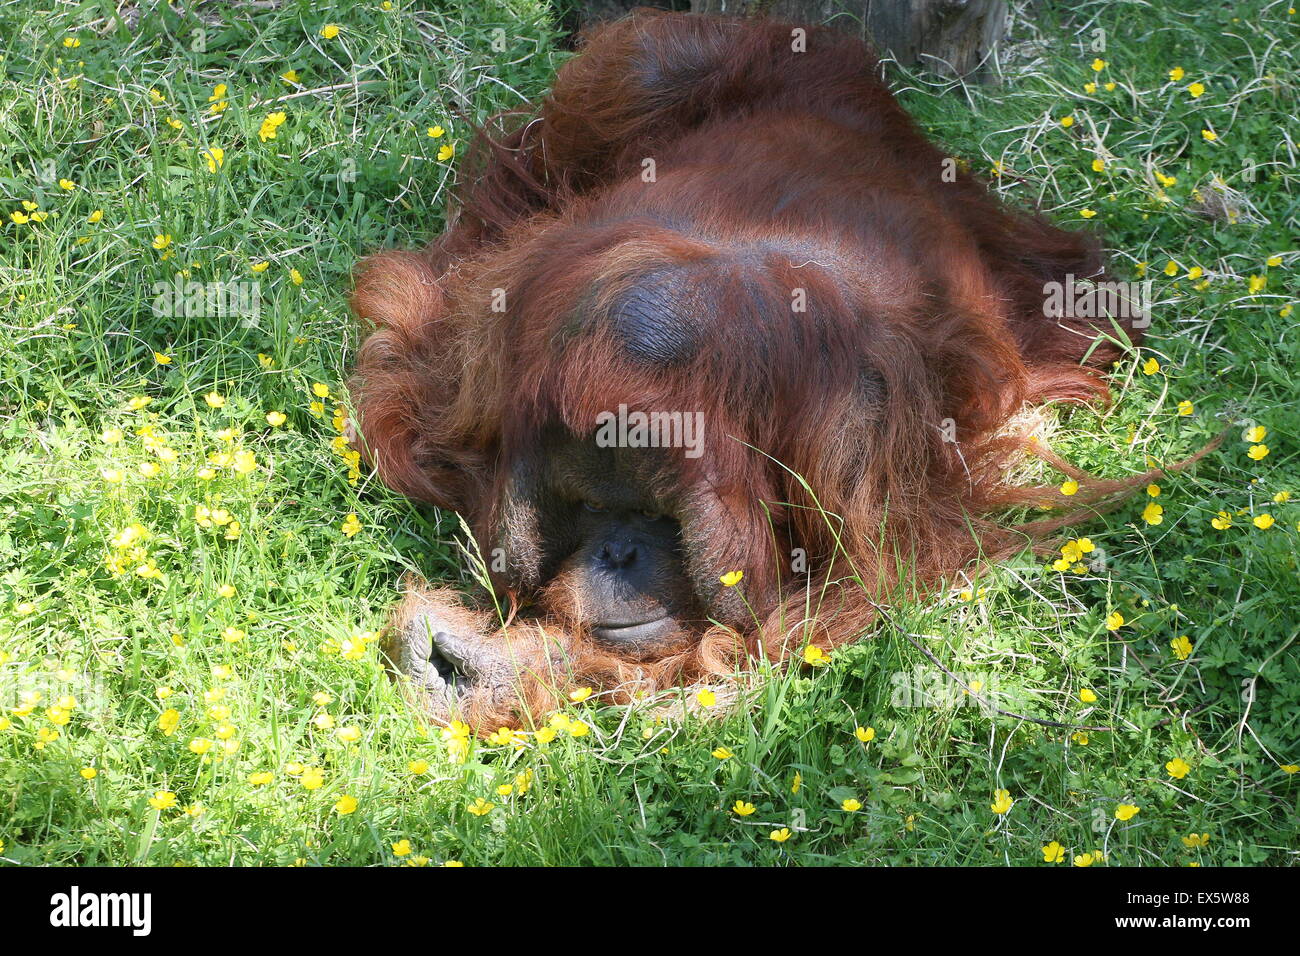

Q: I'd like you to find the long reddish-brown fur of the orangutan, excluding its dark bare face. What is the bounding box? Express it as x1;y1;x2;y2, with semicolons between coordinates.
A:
354;13;1206;727
